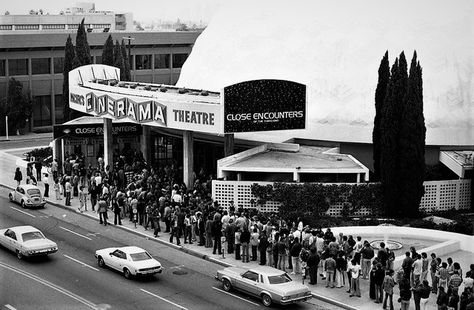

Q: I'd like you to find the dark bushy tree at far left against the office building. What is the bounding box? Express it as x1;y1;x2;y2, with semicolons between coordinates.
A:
3;78;33;135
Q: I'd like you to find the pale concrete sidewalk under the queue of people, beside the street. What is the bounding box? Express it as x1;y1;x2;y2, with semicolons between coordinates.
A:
0;152;466;310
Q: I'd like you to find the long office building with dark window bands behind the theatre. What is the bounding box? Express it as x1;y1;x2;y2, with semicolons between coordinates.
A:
0;30;200;130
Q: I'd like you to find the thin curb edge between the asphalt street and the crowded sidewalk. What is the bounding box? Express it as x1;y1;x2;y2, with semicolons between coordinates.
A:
0;183;358;310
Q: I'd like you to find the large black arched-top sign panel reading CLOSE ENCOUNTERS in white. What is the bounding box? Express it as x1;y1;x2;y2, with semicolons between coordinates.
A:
223;80;306;133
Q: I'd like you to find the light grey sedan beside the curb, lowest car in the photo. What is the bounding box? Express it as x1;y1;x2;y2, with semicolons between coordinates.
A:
215;266;312;307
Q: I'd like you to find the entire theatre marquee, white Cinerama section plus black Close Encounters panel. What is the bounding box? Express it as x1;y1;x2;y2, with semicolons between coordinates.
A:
69;65;306;134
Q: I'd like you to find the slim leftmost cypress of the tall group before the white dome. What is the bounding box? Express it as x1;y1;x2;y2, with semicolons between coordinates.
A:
372;51;390;180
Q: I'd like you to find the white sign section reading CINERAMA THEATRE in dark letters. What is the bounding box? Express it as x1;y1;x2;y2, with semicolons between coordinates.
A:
69;65;222;133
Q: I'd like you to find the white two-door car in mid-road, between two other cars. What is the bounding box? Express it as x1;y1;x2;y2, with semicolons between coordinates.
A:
95;246;163;279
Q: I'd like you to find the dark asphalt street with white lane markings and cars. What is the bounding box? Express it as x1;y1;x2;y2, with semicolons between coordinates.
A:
0;136;339;309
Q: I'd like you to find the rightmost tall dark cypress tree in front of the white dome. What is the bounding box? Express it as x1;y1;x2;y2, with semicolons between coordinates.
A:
399;51;426;216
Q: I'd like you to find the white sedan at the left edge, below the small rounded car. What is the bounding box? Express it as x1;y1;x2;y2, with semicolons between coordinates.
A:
0;226;58;259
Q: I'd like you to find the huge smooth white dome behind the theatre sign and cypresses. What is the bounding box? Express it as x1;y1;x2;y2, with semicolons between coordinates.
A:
177;0;474;145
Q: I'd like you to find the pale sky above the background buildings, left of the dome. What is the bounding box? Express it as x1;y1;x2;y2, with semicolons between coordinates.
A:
0;0;225;23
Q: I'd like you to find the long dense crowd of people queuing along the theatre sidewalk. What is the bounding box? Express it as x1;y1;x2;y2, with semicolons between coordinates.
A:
12;152;474;310
